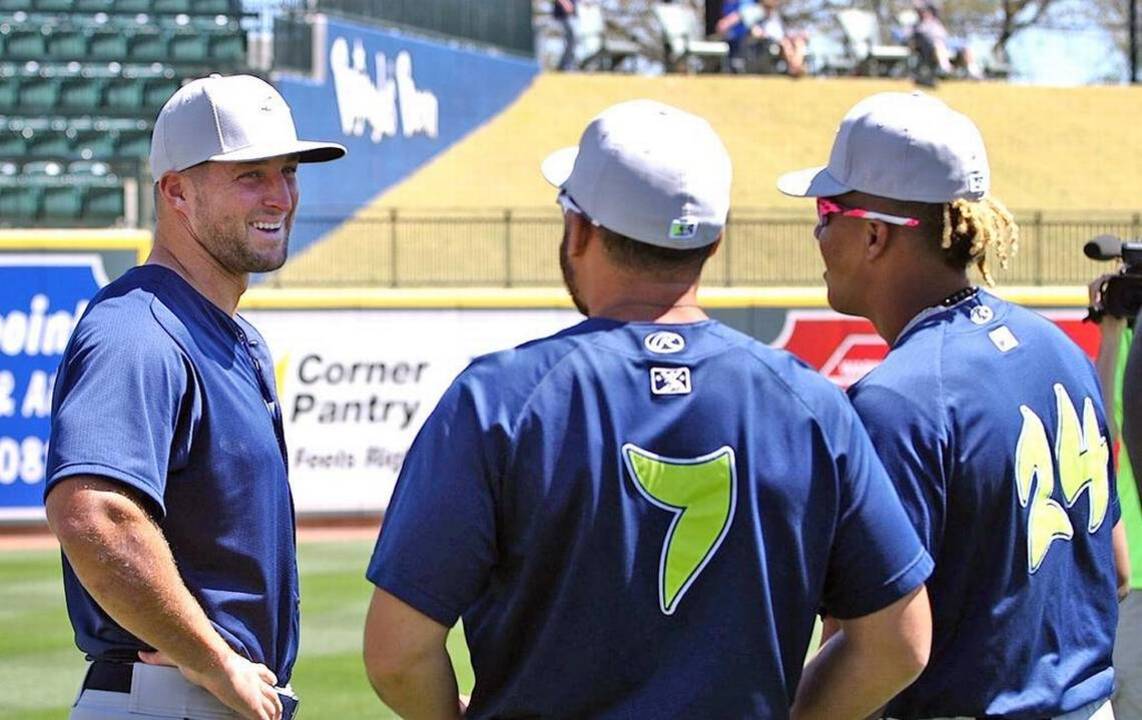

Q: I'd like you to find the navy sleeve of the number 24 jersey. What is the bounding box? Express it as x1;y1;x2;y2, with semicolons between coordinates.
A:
850;384;947;557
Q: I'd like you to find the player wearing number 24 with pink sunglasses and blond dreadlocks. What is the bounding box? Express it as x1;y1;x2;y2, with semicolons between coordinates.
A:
778;93;1121;720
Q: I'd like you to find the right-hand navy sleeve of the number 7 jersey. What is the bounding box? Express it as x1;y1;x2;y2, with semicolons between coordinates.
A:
823;400;933;619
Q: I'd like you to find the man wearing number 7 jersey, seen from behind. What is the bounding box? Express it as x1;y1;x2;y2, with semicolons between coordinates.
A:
365;101;932;720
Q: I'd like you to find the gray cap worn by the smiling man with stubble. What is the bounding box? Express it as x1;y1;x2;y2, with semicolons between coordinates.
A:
151;74;345;182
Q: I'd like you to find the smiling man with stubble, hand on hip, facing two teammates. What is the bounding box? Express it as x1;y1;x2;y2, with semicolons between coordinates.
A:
45;75;345;720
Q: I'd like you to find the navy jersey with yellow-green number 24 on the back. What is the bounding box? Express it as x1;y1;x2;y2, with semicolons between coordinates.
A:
850;291;1119;720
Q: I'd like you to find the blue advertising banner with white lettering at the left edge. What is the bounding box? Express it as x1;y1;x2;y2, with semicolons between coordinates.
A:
0;253;107;520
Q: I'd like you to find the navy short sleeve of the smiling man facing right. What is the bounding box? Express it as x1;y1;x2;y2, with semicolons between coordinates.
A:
45;299;198;517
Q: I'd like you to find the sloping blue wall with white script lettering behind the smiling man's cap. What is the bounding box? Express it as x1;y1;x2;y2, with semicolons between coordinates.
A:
275;18;539;253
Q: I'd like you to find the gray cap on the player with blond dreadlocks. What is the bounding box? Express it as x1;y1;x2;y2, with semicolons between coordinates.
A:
778;93;991;202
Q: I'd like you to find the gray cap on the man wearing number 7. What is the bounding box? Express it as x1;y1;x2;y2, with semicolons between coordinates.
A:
541;99;732;250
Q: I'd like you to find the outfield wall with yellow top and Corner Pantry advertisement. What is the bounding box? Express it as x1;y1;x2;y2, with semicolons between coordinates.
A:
0;238;1097;521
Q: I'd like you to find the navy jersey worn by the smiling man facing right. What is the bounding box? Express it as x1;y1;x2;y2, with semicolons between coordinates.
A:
45;265;298;683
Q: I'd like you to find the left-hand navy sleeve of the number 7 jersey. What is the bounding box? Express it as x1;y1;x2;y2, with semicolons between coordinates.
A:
365;376;498;627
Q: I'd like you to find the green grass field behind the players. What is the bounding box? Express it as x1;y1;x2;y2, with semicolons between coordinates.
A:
0;541;473;720
